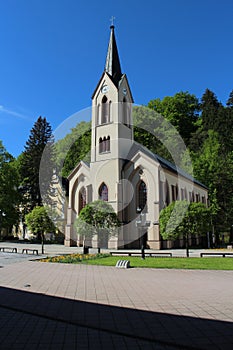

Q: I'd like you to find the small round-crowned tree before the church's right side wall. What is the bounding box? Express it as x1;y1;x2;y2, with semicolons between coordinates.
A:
159;201;209;257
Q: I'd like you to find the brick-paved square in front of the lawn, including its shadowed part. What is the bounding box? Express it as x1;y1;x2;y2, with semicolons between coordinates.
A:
0;243;233;350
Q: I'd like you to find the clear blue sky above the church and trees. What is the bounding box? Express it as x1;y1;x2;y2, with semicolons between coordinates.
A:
0;0;233;156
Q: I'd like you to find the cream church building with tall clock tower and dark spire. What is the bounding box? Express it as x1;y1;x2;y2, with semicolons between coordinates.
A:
65;25;208;249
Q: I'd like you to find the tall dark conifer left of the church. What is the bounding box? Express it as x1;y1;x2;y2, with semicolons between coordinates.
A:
20;117;54;210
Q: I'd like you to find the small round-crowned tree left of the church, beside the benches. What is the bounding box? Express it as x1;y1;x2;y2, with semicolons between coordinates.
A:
25;206;56;254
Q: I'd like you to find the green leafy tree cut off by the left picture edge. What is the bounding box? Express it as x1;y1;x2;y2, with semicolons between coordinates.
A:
0;141;20;231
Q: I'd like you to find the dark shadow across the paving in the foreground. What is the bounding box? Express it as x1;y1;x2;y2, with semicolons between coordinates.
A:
0;285;233;350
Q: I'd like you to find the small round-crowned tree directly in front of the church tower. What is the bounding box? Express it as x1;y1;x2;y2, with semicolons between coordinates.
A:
75;200;120;246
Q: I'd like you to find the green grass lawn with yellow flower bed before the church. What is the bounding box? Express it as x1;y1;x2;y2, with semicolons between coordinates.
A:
41;254;233;270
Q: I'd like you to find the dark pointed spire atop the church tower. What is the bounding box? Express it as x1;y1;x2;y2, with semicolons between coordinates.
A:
104;25;122;85
